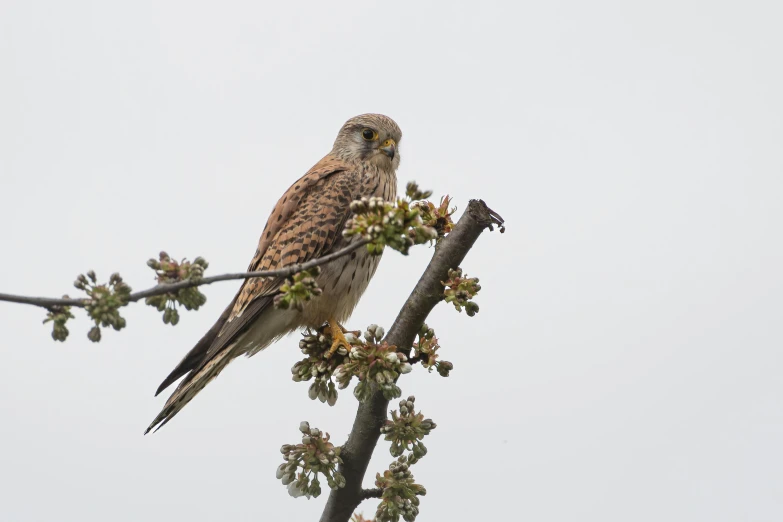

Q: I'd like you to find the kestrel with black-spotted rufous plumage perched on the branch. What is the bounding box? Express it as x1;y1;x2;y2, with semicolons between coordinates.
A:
145;114;402;433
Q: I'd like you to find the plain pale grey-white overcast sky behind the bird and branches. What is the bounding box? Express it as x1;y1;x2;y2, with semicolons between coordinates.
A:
0;0;783;522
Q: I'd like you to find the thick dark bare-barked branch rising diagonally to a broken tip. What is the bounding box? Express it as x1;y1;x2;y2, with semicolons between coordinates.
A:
321;199;498;522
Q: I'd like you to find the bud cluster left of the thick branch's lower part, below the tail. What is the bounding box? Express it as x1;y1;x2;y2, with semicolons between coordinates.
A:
277;422;345;498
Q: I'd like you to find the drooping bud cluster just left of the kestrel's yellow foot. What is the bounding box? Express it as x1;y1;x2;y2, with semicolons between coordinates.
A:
291;325;356;406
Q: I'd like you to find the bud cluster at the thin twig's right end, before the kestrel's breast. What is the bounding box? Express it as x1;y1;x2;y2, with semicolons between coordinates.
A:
343;184;438;255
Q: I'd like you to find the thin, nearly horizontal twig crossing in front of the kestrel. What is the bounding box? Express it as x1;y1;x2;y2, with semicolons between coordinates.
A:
0;239;369;309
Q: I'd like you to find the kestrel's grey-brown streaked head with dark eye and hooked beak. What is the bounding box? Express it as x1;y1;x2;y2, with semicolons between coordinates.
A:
332;114;402;171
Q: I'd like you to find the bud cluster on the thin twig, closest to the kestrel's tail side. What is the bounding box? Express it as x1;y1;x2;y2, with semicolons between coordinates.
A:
144;252;209;326
